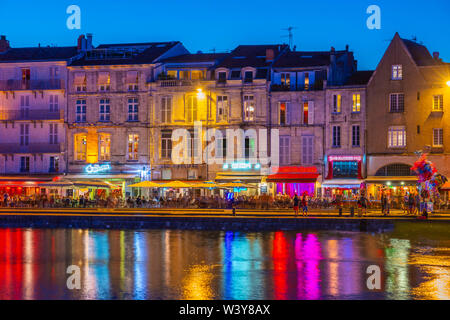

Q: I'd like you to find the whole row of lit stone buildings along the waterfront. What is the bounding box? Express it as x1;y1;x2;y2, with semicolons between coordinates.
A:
0;34;450;196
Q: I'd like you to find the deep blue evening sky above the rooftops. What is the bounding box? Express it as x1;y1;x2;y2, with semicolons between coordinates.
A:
0;0;450;70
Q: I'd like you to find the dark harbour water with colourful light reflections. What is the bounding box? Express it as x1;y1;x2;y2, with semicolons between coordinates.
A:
0;229;450;300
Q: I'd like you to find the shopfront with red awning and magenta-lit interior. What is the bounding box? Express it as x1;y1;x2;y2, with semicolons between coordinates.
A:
267;167;319;197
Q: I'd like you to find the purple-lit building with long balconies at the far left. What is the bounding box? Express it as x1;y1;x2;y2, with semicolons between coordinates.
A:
0;36;78;194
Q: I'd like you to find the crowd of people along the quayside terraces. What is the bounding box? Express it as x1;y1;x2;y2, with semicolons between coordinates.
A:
0;192;450;215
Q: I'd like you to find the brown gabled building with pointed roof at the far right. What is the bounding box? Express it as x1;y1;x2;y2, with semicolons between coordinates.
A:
367;33;450;195
